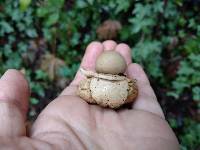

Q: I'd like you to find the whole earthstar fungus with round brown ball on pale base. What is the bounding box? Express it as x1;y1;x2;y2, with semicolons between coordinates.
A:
77;51;138;108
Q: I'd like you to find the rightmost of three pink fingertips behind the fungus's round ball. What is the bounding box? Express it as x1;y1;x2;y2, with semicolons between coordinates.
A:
115;43;132;65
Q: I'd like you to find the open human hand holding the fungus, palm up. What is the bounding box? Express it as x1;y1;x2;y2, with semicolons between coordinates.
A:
0;41;179;150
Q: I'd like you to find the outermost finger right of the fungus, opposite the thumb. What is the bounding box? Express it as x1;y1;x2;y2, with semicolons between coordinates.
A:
127;64;164;118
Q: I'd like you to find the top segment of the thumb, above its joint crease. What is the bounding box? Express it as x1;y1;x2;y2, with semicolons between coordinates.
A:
0;69;30;116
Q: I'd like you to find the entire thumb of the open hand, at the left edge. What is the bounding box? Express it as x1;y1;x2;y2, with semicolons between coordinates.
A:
0;69;29;137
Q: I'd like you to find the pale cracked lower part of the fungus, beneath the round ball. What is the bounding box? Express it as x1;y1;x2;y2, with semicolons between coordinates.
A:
77;69;138;108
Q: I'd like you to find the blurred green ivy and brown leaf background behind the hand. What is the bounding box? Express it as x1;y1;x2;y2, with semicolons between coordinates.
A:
0;0;200;150
